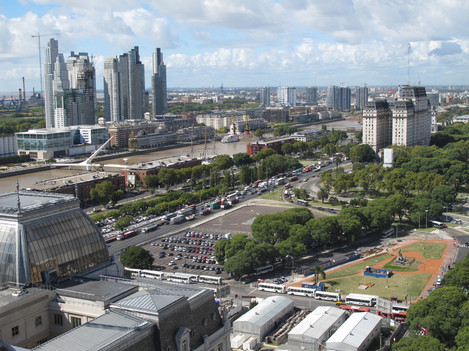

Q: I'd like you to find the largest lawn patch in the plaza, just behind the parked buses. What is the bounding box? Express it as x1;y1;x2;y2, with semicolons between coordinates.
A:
326;273;432;300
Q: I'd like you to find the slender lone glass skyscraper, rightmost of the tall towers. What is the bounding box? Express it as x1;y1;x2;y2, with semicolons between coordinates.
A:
151;48;168;118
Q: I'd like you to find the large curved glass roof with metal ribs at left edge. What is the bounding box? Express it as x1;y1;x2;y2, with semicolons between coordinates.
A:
0;191;109;284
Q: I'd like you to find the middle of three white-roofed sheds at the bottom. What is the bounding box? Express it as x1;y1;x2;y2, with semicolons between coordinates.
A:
288;306;347;350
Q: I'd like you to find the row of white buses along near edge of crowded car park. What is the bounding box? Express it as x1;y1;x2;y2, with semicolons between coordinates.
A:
125;267;223;285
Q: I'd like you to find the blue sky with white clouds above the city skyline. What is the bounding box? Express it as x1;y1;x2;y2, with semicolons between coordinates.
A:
0;0;469;92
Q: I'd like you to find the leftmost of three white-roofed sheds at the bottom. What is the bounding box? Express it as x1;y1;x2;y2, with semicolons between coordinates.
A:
232;296;294;343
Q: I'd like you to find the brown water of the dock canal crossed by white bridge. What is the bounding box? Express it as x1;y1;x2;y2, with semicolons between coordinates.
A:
0;120;362;193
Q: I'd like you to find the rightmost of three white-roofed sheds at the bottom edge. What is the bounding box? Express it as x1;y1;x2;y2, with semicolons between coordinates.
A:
326;312;381;351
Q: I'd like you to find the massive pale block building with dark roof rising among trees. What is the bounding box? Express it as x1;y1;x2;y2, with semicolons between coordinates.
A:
363;85;431;151
